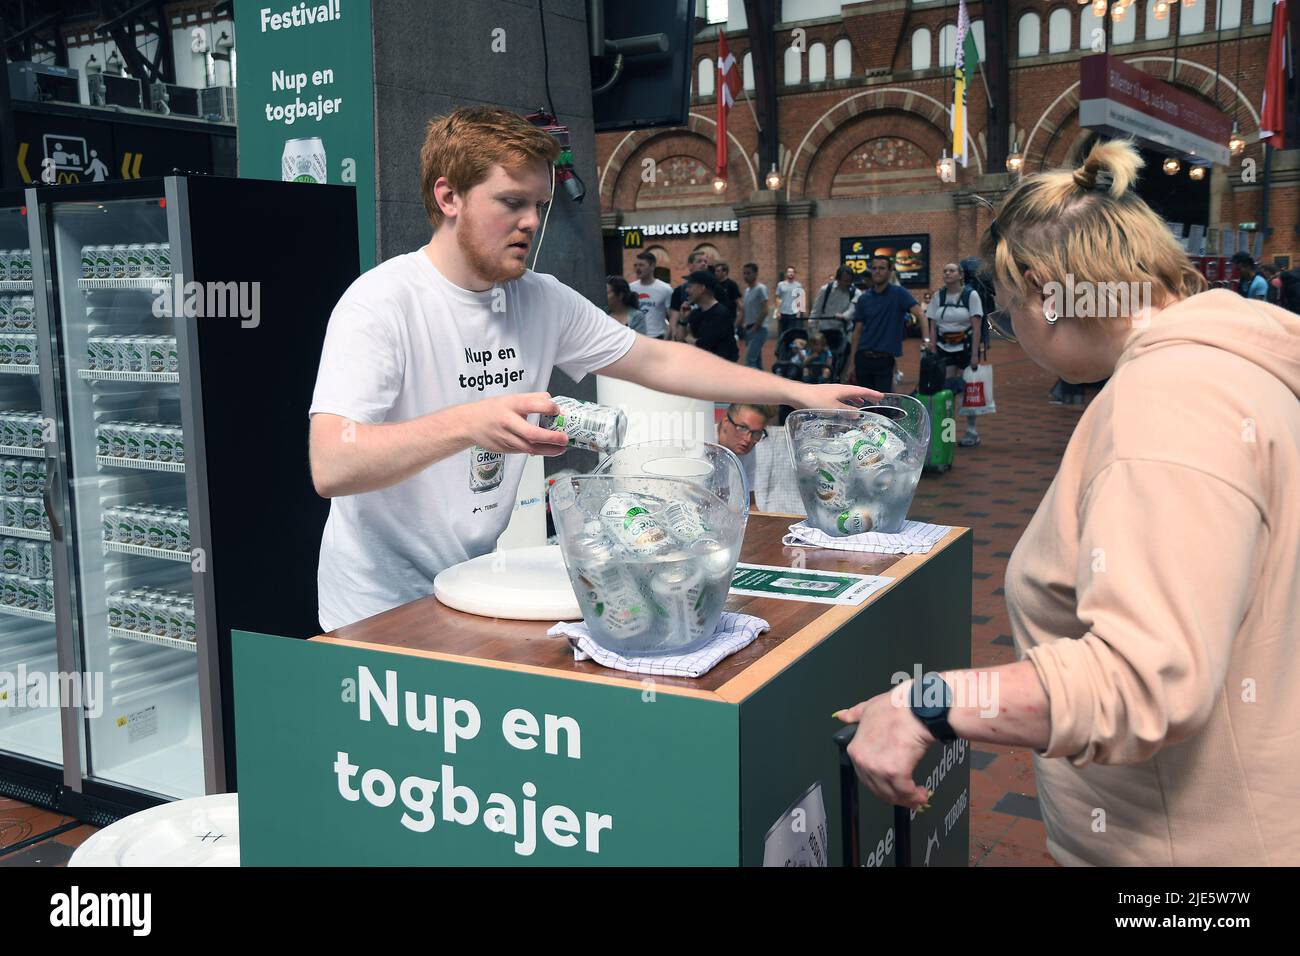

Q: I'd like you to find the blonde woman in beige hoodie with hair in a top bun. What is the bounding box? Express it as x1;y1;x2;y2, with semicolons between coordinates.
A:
839;142;1300;866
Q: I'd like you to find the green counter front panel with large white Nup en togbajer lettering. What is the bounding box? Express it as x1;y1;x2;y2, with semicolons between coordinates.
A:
234;631;740;866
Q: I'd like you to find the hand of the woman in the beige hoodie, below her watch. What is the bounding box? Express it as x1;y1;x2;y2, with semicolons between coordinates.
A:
835;680;935;810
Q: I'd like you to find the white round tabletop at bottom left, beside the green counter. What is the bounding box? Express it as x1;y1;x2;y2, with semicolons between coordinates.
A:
68;793;239;866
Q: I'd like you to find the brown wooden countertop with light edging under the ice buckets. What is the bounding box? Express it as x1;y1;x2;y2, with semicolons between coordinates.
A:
312;512;967;702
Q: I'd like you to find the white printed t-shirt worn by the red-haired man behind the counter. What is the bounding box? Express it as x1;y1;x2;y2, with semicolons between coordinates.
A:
309;250;636;631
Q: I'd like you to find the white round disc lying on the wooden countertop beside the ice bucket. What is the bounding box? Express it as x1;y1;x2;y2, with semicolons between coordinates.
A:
433;545;582;620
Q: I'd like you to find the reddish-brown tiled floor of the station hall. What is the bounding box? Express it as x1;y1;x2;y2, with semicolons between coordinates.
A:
0;339;1091;866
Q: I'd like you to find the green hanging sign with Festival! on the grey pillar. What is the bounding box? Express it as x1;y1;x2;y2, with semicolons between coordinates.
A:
234;0;376;271
